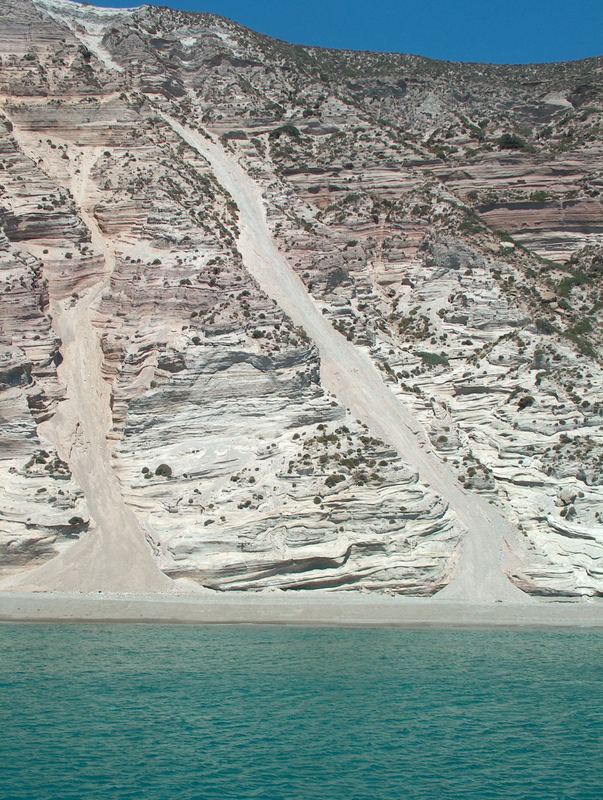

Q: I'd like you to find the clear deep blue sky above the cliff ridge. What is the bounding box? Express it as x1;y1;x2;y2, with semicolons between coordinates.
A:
87;0;603;63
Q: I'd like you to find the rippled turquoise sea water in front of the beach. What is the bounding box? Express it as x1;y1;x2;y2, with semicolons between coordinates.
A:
0;625;603;800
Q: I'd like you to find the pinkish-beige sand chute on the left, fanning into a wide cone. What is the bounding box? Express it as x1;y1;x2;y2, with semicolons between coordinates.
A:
2;144;173;592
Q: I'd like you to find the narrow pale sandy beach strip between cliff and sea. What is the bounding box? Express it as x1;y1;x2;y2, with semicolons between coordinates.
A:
0;590;603;629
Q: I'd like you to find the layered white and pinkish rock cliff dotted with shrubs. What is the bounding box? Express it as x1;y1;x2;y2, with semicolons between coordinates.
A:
0;0;603;600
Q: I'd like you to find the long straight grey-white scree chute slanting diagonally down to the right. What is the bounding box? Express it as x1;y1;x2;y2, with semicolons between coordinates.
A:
162;113;529;602
